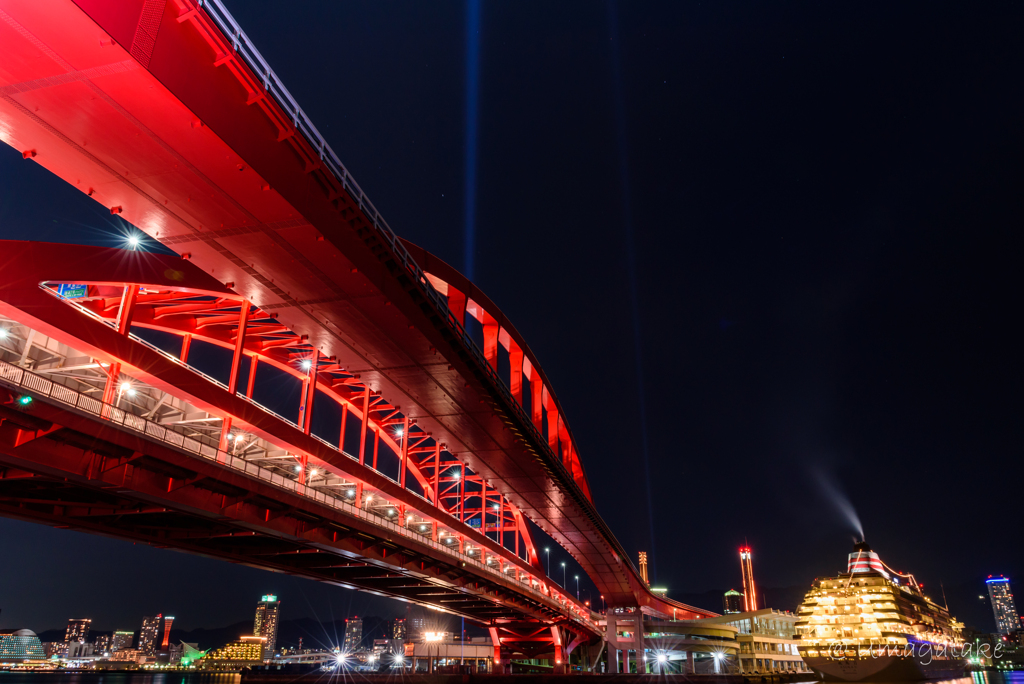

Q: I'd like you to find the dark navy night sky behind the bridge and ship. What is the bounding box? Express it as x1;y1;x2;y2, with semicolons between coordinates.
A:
0;0;1024;629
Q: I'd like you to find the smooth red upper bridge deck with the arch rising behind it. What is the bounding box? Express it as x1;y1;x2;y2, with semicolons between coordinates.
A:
0;0;708;616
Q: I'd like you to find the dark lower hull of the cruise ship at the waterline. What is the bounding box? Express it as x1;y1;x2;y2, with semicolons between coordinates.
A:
804;655;967;682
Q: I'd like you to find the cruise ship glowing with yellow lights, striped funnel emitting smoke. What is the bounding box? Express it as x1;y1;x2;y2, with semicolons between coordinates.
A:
797;542;966;682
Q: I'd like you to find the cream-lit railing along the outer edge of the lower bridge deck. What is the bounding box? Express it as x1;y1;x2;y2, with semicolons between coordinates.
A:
0;360;597;629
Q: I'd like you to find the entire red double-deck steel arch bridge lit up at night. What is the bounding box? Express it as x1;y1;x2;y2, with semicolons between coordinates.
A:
0;0;712;664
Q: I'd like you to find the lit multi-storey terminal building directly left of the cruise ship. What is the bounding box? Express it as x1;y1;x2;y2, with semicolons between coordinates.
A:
700;608;808;675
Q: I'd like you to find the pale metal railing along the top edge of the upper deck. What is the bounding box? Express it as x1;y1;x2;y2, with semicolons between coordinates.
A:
197;0;578;501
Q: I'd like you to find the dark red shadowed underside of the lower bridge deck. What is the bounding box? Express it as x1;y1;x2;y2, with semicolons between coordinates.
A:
0;388;577;625
